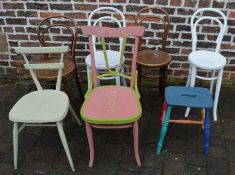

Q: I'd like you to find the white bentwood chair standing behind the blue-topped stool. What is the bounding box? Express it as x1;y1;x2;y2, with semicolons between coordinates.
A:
185;8;227;121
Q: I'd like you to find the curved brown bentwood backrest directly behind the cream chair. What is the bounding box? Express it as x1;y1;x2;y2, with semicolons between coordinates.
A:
37;15;78;62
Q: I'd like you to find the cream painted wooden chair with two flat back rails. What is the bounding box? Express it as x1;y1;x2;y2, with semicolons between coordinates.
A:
9;46;80;171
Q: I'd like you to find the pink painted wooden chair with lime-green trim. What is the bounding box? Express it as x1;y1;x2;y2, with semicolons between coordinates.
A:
81;26;145;167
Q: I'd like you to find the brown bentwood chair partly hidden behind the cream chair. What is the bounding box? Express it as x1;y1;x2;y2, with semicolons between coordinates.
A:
35;16;84;100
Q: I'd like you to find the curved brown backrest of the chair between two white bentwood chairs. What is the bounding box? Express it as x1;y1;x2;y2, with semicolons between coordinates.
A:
135;7;170;51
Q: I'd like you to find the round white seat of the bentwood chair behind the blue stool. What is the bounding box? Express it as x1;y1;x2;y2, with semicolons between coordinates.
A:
189;50;226;70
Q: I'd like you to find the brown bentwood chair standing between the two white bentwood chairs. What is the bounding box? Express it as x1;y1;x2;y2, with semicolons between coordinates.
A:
135;7;171;97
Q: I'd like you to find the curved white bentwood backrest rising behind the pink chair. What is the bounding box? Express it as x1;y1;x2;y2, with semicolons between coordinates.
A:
87;7;126;52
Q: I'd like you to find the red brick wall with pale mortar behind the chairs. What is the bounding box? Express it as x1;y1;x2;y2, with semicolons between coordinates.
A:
0;0;235;85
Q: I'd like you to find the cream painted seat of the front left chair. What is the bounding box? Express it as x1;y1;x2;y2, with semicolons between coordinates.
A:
9;90;69;123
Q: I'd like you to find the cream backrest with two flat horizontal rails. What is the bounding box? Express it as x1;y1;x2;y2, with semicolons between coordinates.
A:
14;46;68;90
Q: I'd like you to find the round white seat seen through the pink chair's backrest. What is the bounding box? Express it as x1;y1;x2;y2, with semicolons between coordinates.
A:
85;50;125;69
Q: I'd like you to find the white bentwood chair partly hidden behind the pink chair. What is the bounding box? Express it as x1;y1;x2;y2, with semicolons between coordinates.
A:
85;7;126;87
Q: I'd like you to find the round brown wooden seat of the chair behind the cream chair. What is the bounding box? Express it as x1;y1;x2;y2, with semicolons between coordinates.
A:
34;58;75;81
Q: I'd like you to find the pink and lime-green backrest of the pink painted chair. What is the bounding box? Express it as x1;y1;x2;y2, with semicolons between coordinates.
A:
82;26;145;88
